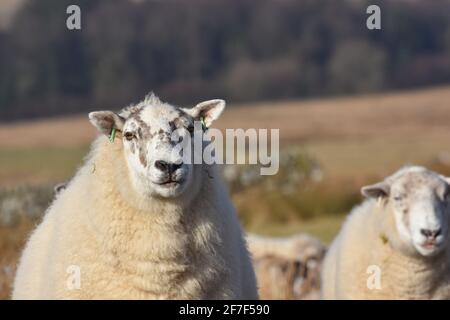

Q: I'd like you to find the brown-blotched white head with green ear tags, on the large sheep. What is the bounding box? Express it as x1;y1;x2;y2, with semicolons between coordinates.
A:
89;95;225;198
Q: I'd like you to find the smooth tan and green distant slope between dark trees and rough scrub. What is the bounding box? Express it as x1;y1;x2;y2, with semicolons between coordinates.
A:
0;86;450;185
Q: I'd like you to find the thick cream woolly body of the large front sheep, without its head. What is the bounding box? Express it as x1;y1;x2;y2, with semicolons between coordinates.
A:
12;125;257;299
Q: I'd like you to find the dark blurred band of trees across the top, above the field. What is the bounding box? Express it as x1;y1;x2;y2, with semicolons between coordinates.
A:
0;0;450;121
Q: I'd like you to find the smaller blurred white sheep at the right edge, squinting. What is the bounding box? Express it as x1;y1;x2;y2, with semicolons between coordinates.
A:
321;166;450;299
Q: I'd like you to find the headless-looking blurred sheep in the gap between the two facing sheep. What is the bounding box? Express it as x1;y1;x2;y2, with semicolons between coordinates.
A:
247;234;325;299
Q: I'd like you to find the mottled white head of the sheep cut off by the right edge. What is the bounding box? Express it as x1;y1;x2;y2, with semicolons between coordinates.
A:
362;166;450;257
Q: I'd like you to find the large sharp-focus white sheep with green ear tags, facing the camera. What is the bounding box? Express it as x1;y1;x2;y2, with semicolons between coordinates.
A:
12;95;258;299
